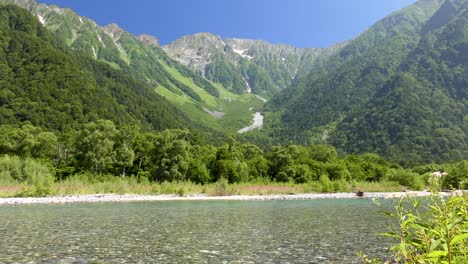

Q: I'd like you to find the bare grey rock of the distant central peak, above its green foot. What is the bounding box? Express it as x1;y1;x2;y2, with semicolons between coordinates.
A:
162;33;347;89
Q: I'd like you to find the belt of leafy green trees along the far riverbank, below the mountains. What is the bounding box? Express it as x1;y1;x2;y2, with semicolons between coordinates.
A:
0;120;468;194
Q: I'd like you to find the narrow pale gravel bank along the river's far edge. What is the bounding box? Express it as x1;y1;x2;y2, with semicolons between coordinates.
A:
0;191;461;205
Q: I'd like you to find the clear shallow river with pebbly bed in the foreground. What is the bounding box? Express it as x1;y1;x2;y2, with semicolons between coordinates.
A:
0;199;390;263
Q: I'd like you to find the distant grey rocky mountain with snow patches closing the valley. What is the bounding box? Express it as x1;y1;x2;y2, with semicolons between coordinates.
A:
163;33;345;98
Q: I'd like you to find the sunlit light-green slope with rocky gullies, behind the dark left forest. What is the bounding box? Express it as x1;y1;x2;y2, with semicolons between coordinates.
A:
0;0;261;132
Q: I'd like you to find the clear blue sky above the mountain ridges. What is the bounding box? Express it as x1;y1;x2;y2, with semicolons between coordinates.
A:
39;0;415;47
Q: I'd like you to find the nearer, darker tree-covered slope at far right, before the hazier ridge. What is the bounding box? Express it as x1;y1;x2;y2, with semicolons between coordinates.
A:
332;1;468;162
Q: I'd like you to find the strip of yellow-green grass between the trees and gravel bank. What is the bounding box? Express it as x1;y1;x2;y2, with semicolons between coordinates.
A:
0;175;405;197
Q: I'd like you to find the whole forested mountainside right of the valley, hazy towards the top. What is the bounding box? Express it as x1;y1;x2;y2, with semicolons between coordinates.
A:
269;0;468;163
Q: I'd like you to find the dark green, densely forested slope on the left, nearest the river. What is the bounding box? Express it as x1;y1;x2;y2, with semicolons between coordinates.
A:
0;5;190;131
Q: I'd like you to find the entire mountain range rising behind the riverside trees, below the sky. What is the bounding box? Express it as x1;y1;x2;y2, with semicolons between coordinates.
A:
0;0;468;165
